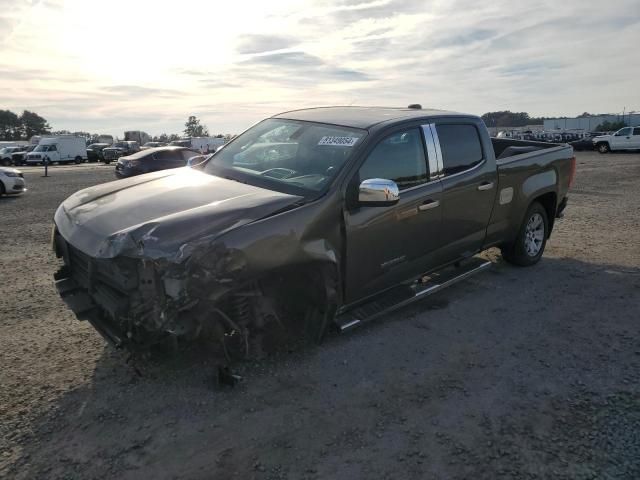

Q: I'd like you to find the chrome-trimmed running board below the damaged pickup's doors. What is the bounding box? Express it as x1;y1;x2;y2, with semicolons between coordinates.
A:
335;258;491;332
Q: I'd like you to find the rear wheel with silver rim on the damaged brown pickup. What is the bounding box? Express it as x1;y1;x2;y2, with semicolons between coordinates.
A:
502;202;549;267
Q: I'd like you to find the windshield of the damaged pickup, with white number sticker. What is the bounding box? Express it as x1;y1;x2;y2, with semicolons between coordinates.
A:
203;118;366;192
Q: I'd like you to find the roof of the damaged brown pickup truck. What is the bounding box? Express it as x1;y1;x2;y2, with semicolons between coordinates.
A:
272;107;466;129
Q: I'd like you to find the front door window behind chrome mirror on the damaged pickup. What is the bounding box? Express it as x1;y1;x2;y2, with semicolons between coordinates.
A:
359;128;429;190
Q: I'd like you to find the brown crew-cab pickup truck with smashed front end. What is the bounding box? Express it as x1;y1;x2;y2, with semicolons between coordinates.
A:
53;105;575;353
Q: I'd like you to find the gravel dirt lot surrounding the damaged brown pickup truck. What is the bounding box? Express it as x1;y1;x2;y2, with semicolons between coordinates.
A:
0;153;640;479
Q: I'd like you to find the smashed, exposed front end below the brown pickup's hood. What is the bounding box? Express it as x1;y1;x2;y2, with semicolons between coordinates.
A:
53;229;320;360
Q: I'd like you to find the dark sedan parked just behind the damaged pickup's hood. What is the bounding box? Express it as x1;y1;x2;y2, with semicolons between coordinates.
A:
116;147;198;178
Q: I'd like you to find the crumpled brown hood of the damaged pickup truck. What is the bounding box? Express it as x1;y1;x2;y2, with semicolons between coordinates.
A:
55;168;302;262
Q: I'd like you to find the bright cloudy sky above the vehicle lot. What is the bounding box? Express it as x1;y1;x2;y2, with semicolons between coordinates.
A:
0;0;640;135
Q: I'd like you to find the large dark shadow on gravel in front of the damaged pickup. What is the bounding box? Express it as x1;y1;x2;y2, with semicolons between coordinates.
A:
7;258;640;479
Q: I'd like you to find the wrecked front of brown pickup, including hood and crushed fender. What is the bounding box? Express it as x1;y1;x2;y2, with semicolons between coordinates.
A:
53;169;340;357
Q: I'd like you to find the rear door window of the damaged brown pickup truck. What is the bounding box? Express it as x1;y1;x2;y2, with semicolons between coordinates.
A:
436;124;483;176
